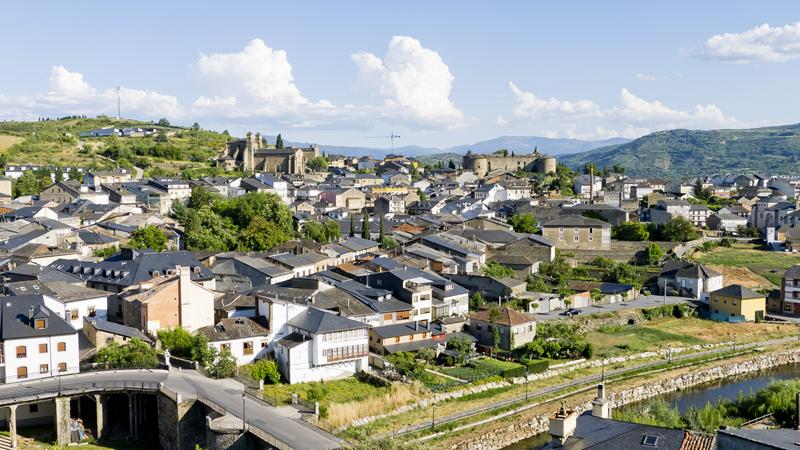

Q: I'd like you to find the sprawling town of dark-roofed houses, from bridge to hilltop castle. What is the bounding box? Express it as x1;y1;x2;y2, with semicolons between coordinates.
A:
0;118;800;448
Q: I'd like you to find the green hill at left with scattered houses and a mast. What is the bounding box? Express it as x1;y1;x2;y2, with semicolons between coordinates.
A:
0;116;229;176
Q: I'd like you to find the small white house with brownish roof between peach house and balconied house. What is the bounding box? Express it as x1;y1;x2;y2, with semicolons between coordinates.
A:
196;317;269;366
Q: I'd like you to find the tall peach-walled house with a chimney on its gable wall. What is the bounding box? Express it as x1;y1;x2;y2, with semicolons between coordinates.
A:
120;266;215;333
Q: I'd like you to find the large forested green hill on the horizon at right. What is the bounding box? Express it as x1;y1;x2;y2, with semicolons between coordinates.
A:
561;124;800;177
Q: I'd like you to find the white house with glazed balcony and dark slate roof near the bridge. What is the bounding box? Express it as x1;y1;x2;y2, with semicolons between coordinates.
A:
275;308;369;384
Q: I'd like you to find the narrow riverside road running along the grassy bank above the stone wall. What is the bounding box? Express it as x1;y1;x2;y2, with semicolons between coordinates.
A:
376;337;797;439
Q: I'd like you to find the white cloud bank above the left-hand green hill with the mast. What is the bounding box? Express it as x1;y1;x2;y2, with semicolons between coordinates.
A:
0;65;184;119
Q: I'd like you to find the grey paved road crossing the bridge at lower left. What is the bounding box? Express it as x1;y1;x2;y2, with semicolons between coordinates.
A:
0;369;342;449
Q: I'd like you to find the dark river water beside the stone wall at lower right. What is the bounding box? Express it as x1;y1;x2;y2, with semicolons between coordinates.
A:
503;364;800;450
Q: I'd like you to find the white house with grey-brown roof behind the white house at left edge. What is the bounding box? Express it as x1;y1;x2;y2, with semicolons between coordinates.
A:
5;281;109;330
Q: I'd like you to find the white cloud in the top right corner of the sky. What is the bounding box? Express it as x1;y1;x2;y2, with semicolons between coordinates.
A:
696;21;800;63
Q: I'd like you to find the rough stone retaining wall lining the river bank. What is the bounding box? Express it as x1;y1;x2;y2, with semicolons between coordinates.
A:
451;350;800;450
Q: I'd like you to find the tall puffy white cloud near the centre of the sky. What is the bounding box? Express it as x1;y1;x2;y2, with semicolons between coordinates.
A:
350;36;464;128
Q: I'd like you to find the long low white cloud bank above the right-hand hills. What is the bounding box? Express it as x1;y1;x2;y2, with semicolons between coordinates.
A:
498;82;745;139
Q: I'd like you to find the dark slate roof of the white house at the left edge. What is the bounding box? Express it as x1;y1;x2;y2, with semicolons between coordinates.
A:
0;295;78;341
